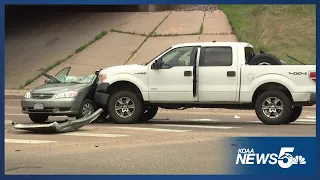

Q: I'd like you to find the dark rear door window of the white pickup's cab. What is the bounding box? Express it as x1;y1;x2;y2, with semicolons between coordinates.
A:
200;47;232;66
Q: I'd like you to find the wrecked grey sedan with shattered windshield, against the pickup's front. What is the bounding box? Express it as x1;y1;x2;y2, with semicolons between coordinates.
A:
21;67;98;123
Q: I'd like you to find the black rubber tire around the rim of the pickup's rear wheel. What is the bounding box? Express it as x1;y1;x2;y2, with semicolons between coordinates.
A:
255;90;292;125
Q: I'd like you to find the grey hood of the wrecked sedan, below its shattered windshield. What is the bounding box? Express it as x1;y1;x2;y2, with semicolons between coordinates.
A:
31;83;87;94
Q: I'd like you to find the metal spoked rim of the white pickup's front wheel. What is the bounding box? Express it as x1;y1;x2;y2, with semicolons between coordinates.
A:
114;97;136;118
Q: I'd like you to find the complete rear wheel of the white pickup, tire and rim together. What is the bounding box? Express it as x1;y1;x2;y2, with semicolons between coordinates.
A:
255;90;292;125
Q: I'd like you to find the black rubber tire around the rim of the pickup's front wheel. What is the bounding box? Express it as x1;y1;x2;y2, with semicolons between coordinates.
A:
108;90;144;124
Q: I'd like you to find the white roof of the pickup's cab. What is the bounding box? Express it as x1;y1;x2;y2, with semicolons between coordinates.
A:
172;41;251;48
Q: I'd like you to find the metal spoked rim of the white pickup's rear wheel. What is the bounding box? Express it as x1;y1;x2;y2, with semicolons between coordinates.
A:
262;97;283;119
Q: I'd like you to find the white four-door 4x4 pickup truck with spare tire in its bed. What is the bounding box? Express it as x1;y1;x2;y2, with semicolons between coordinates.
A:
95;41;316;125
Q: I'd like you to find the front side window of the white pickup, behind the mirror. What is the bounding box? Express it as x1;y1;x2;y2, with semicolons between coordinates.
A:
162;47;193;67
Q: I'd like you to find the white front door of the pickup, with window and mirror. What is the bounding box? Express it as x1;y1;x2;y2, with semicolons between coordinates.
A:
148;46;197;103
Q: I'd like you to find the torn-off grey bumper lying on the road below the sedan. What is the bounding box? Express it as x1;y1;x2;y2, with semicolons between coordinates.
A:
13;108;103;133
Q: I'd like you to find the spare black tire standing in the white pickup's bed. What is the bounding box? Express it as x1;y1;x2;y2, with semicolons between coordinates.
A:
249;53;282;65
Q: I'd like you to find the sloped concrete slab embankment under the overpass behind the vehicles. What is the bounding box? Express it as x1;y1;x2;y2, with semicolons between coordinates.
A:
5;5;229;95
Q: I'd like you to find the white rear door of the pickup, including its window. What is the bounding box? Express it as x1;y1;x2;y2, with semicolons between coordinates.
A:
198;46;240;103
